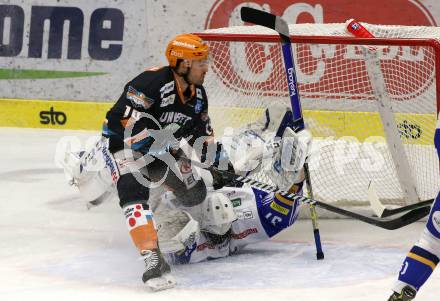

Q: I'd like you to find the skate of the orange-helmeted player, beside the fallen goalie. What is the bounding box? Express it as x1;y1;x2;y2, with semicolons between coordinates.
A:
142;249;176;292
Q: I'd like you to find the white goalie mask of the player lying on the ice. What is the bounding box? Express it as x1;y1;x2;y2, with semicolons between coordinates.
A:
200;192;237;235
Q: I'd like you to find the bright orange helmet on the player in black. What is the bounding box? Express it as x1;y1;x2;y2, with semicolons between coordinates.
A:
165;34;209;67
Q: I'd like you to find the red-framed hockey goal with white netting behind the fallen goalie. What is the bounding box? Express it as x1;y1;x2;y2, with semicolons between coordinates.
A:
198;24;440;206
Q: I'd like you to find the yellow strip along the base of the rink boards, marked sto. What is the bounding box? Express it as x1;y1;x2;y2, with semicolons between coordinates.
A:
0;99;436;145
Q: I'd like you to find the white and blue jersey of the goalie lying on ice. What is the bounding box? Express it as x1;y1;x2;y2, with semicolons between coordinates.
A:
168;185;300;264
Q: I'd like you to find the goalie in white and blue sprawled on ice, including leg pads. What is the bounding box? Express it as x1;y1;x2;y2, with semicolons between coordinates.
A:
61;105;311;278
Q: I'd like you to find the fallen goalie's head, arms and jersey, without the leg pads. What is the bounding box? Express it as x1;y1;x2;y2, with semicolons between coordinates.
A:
155;171;302;264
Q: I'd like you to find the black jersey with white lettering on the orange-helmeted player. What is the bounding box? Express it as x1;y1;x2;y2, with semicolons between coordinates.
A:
103;67;212;153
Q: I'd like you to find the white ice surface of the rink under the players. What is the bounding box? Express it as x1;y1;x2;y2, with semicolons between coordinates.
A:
0;128;440;301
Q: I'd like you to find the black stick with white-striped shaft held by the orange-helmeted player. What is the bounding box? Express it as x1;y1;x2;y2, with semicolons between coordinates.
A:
185;157;431;230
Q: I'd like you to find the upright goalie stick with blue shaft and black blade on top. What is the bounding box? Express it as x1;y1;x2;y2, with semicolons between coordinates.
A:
241;7;324;260
